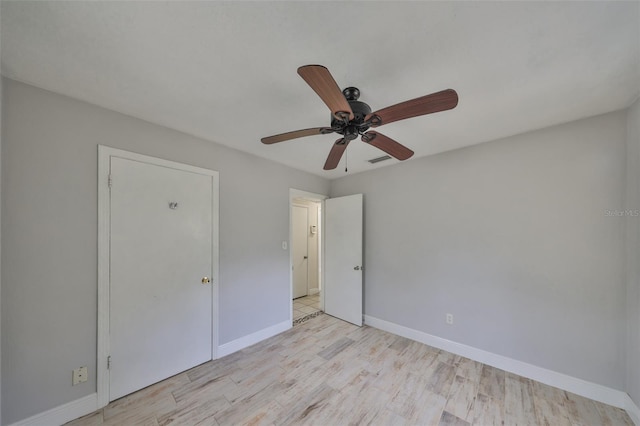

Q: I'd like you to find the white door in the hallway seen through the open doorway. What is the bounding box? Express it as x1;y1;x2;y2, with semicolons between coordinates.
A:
291;206;309;299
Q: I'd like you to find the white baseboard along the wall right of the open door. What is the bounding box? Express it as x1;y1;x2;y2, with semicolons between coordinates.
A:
364;315;640;426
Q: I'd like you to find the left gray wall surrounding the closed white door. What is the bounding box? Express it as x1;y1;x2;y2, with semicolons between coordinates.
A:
1;79;329;424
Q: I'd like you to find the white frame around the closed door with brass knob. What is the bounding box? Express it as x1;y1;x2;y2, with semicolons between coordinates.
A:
96;145;220;408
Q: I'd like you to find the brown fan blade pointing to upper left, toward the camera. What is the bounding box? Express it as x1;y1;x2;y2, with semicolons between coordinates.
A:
298;65;354;120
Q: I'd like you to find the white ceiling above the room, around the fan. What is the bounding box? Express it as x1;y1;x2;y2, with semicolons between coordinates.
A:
0;1;640;179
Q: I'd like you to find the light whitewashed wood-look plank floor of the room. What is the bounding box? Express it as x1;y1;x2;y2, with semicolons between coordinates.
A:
68;315;633;426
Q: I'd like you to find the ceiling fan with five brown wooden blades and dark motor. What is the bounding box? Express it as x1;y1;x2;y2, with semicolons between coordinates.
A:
261;65;458;170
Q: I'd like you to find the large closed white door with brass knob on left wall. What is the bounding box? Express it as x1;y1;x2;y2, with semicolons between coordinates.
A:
109;157;212;401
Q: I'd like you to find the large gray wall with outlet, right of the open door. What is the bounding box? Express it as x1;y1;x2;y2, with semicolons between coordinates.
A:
331;112;626;390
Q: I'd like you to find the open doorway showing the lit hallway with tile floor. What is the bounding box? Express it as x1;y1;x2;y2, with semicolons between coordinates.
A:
289;189;327;325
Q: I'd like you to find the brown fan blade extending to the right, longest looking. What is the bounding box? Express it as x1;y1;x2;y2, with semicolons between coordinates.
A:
366;89;458;127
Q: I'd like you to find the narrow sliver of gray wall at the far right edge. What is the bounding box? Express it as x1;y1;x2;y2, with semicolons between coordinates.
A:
626;97;640;407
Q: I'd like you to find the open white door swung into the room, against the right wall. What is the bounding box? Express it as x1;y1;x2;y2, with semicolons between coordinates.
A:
324;194;362;325
